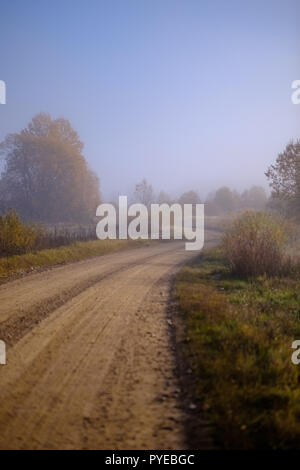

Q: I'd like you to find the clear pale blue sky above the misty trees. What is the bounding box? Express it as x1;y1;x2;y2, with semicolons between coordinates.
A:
0;0;300;198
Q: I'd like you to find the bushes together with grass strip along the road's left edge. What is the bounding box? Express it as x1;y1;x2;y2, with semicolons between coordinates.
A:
0;211;146;283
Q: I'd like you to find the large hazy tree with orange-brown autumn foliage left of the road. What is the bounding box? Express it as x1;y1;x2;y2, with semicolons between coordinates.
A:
0;113;100;222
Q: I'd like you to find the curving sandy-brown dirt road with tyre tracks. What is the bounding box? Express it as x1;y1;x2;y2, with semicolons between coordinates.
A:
0;242;216;449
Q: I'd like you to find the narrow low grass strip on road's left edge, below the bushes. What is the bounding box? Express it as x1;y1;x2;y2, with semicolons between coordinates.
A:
0;239;149;283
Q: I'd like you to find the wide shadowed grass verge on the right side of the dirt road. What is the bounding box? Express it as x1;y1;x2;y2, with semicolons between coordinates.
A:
176;250;300;449
